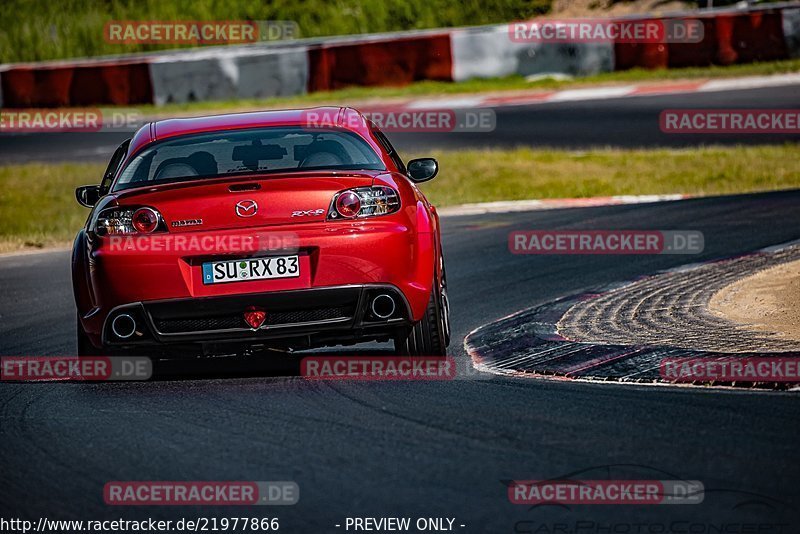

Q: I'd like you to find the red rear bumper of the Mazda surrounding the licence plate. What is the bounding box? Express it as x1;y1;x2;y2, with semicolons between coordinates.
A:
73;217;437;347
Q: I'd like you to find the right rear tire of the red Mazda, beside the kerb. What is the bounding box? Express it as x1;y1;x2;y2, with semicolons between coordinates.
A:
394;271;450;356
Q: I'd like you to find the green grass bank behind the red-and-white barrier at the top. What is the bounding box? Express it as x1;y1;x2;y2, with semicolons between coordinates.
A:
0;0;552;63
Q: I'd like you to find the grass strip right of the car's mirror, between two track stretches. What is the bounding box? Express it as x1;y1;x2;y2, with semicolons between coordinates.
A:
423;144;800;206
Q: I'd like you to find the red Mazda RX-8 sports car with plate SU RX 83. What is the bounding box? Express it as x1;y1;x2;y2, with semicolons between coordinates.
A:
72;108;450;356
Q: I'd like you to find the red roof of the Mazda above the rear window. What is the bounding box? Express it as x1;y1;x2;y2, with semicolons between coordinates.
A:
128;106;371;156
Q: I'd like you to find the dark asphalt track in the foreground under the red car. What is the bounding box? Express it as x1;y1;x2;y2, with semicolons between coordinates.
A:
0;190;800;533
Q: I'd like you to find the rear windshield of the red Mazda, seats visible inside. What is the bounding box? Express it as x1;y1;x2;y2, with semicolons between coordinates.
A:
114;127;386;191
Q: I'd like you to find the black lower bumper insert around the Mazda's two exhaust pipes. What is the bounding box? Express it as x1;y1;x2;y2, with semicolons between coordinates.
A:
102;284;412;348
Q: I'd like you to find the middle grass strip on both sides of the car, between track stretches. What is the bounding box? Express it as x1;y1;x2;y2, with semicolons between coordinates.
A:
0;144;800;255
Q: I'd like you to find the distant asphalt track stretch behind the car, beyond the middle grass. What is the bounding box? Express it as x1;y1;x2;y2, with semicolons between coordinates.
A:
0;86;800;164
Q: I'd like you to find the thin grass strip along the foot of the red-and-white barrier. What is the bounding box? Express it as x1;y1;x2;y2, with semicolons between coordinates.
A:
136;59;800;115
